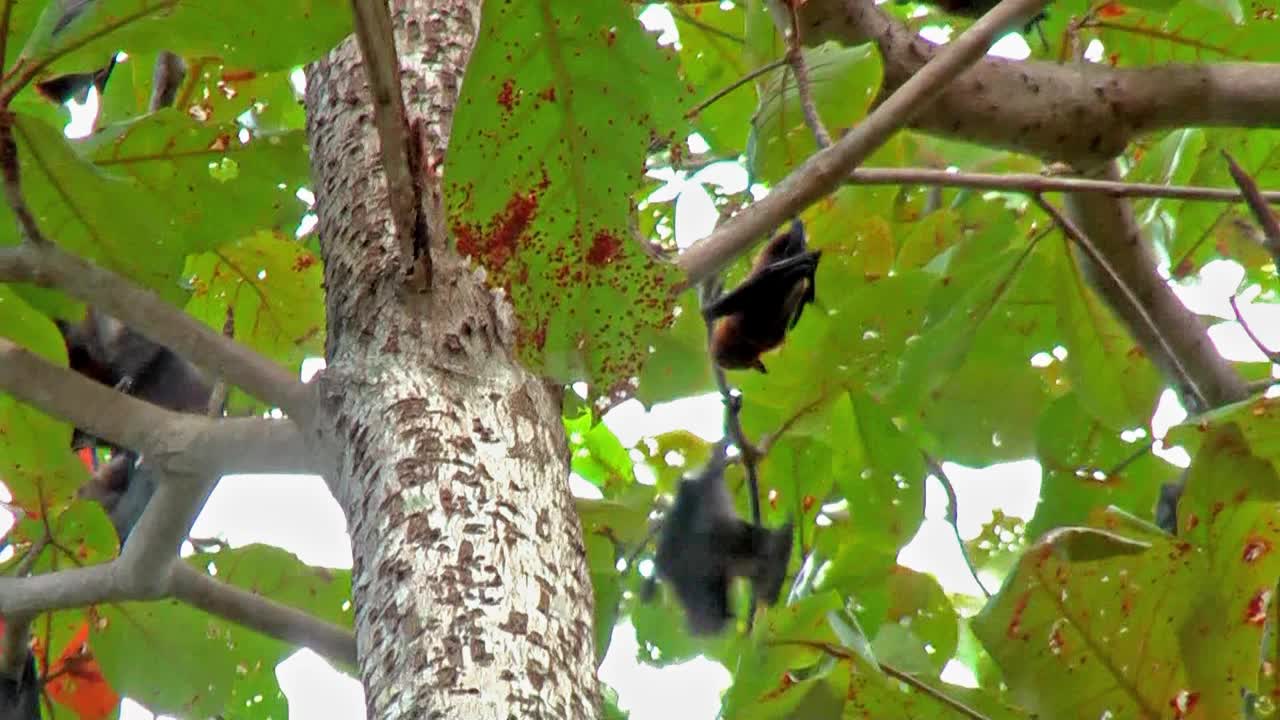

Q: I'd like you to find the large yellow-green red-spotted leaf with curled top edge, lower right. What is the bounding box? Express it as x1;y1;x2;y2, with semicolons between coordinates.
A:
973;520;1203;719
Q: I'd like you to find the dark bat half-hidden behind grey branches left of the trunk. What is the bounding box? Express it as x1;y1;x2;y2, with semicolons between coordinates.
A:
58;307;212;544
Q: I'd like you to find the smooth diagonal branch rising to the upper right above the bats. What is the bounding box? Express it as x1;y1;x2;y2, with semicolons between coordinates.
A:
677;0;1046;284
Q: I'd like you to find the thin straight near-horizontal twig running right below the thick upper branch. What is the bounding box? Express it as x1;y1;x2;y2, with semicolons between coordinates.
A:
845;168;1280;202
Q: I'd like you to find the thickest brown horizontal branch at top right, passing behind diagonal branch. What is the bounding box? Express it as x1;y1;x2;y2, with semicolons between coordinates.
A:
799;0;1280;169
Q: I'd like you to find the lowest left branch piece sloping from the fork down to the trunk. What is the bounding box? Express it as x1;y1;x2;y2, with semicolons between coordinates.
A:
172;562;356;667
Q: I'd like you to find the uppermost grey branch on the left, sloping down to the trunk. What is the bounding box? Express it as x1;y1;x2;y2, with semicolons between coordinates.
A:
0;240;314;427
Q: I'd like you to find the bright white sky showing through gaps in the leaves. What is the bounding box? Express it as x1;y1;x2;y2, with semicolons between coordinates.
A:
27;8;1280;720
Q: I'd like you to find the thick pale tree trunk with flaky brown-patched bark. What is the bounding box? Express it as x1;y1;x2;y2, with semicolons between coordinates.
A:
306;0;599;720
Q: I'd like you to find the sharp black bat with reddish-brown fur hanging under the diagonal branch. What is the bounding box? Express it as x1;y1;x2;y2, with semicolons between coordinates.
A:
704;220;822;373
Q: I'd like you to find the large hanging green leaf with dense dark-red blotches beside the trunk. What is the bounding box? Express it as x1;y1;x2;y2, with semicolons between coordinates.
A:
445;0;687;397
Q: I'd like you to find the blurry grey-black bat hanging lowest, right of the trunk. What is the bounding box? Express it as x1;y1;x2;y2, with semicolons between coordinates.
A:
654;445;791;635
